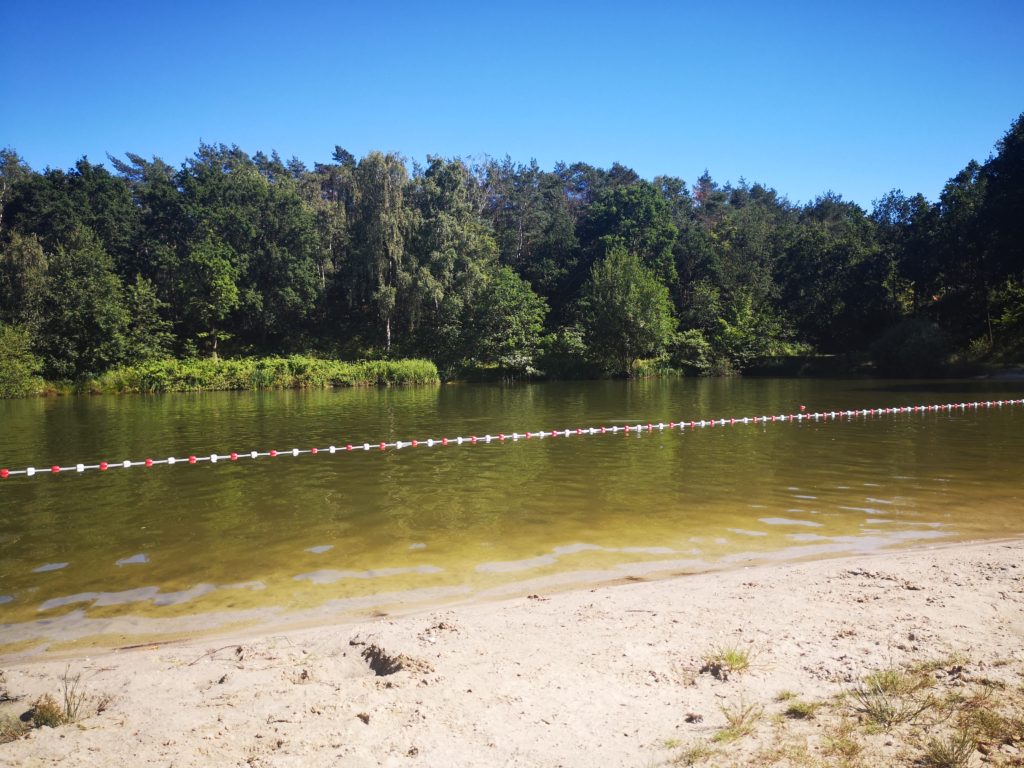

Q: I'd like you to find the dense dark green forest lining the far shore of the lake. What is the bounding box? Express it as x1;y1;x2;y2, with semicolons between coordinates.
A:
0;115;1024;394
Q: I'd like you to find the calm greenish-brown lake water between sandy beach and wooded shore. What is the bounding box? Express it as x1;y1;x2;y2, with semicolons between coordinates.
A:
0;379;1024;652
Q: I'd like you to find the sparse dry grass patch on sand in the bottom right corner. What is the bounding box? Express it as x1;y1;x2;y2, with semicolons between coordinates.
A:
663;649;1024;768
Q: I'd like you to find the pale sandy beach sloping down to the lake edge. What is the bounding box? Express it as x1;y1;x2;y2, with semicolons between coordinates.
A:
0;540;1024;768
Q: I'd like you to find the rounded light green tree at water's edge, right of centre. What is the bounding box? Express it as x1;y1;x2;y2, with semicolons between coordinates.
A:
581;246;676;376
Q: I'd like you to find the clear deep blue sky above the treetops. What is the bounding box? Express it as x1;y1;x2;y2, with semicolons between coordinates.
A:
0;0;1024;207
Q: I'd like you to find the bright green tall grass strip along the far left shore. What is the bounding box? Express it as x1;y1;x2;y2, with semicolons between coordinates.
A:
81;355;439;393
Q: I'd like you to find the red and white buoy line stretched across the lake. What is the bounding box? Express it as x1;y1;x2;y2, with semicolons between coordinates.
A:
0;398;1024;480
